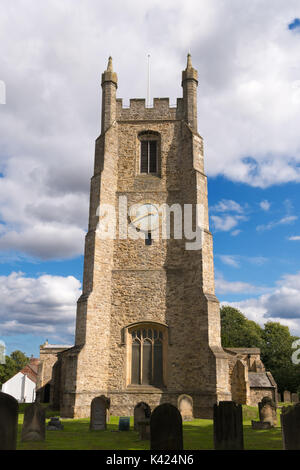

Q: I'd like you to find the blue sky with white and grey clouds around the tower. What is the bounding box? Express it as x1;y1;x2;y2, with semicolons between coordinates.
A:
0;0;300;356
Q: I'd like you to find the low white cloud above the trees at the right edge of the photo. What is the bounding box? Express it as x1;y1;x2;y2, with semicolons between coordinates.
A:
224;272;300;335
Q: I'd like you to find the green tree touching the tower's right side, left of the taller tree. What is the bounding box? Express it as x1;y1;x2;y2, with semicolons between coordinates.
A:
220;305;263;348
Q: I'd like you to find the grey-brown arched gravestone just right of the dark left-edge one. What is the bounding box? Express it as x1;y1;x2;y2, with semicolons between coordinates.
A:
21;403;46;441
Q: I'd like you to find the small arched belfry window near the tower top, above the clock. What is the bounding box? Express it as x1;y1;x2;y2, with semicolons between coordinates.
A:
139;131;160;174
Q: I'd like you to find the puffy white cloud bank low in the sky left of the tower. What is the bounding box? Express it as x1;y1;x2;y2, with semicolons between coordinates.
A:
0;272;81;342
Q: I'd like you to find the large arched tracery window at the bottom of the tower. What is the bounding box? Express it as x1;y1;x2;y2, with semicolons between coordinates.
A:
129;325;166;387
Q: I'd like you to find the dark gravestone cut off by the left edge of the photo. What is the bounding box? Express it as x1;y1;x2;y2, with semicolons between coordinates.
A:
0;392;19;450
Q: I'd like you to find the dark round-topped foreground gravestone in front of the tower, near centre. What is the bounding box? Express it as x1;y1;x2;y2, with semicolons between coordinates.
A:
150;403;183;450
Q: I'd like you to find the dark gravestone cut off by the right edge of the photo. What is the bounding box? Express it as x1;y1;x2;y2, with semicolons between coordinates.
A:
281;403;300;450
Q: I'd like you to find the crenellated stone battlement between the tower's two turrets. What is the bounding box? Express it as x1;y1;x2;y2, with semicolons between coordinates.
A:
117;98;183;121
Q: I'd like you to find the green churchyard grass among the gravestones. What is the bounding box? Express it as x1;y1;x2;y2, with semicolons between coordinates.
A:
17;406;282;450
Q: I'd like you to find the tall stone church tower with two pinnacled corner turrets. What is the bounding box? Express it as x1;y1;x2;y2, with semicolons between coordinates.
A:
59;55;231;417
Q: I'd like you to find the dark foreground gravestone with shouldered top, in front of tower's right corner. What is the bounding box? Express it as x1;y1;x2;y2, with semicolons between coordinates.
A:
214;401;244;450
